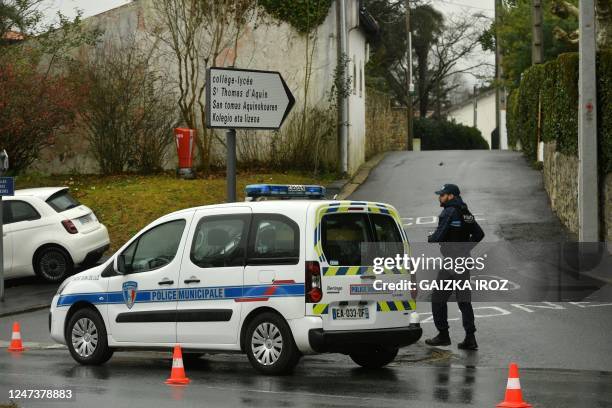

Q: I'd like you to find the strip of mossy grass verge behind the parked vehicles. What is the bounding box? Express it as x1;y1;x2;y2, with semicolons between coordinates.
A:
15;172;333;253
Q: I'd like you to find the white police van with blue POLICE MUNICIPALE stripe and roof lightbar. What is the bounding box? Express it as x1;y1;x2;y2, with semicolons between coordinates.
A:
49;185;422;374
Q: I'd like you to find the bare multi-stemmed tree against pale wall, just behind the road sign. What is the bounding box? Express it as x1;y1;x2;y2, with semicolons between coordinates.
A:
153;0;256;170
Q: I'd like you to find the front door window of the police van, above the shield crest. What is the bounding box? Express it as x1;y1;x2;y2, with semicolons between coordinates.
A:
120;220;185;273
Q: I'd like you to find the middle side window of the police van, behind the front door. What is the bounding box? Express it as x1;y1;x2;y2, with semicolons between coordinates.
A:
190;215;250;268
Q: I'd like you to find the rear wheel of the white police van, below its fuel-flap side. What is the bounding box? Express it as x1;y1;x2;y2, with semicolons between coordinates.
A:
245;313;300;375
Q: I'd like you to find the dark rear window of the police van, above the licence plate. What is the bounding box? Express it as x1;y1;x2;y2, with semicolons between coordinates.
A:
321;213;403;266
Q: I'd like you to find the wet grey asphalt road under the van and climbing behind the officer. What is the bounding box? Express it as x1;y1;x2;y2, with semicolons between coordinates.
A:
0;151;612;408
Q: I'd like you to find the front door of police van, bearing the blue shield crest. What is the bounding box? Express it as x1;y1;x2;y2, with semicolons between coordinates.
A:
107;212;193;344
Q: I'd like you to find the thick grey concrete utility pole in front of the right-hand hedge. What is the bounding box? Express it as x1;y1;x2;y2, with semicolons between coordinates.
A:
578;0;599;242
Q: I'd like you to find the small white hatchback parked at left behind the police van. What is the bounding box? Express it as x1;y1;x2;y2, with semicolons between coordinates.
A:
2;187;110;282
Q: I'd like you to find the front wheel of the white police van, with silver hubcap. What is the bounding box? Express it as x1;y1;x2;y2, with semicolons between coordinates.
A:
66;308;113;365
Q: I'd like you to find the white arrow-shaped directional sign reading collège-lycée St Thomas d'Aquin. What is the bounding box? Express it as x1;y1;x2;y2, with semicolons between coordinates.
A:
206;68;295;129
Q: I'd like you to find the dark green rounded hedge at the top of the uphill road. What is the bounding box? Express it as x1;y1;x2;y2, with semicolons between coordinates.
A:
413;118;489;150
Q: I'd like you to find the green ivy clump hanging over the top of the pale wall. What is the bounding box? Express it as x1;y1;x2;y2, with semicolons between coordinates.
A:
259;0;332;34
